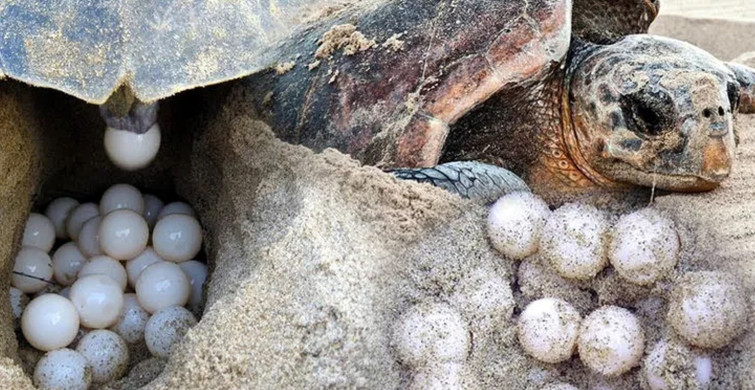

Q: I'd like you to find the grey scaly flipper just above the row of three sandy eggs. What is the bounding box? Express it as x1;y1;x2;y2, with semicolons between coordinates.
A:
388;161;530;203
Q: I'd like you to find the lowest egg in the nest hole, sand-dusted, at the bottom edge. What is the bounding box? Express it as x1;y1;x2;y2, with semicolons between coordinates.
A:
34;348;92;390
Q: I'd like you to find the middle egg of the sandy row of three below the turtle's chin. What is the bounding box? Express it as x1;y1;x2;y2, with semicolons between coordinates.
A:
540;203;608;279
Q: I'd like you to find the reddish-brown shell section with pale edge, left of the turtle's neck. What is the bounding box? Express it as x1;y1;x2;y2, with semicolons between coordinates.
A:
245;0;570;168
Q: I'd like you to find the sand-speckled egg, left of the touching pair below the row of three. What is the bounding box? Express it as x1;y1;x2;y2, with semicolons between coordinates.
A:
517;298;581;363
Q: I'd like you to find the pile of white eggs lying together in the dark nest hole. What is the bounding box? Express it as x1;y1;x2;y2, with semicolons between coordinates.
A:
10;184;207;389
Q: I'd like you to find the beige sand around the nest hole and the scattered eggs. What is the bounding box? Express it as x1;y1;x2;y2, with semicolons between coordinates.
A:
0;13;755;390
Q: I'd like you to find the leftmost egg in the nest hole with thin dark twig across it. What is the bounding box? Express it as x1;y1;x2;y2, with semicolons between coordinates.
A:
11;246;52;294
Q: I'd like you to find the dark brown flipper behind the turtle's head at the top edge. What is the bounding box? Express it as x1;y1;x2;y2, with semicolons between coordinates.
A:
572;0;661;43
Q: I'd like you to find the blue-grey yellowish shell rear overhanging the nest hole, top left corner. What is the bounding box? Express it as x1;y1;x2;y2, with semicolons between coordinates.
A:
0;0;352;104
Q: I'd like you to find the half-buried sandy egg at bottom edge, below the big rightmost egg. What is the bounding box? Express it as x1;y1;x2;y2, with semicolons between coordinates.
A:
642;339;713;390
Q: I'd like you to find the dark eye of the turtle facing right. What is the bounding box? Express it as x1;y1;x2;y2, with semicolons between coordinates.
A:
619;90;674;136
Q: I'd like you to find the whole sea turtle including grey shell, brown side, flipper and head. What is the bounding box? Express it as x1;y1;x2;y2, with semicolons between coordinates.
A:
0;0;755;198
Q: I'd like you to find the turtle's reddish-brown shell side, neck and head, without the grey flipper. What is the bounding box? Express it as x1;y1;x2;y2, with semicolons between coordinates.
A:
233;0;755;199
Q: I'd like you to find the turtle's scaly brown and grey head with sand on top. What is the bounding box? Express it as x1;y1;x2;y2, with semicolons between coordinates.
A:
564;35;749;191
